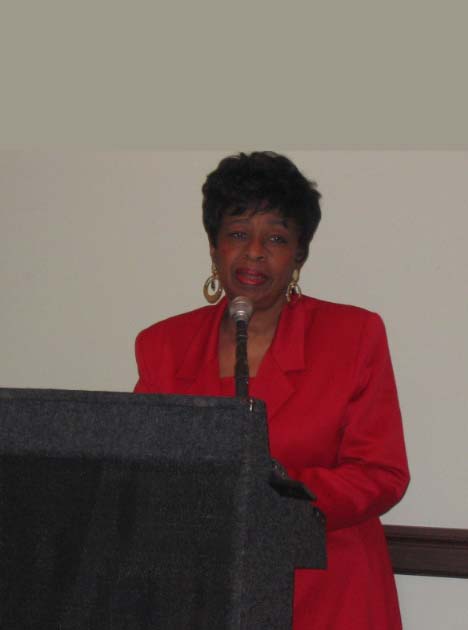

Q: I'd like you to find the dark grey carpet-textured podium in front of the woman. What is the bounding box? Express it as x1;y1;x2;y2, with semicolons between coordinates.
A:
0;389;326;630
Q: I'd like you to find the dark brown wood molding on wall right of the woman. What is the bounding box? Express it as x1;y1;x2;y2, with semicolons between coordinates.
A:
384;525;468;578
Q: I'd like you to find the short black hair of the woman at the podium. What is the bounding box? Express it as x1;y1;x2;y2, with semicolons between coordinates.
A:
202;151;322;262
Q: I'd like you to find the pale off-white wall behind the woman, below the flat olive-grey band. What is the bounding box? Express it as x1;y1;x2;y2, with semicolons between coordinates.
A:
0;148;468;630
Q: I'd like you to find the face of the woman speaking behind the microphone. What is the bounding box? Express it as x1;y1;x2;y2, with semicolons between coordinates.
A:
210;210;300;310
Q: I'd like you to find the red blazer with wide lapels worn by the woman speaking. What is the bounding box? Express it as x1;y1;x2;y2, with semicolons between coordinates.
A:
135;296;409;630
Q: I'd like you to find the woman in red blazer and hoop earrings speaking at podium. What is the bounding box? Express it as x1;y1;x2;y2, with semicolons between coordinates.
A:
135;152;409;630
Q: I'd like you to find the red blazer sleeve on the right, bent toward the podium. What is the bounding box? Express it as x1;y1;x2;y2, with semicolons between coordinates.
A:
288;313;409;530
